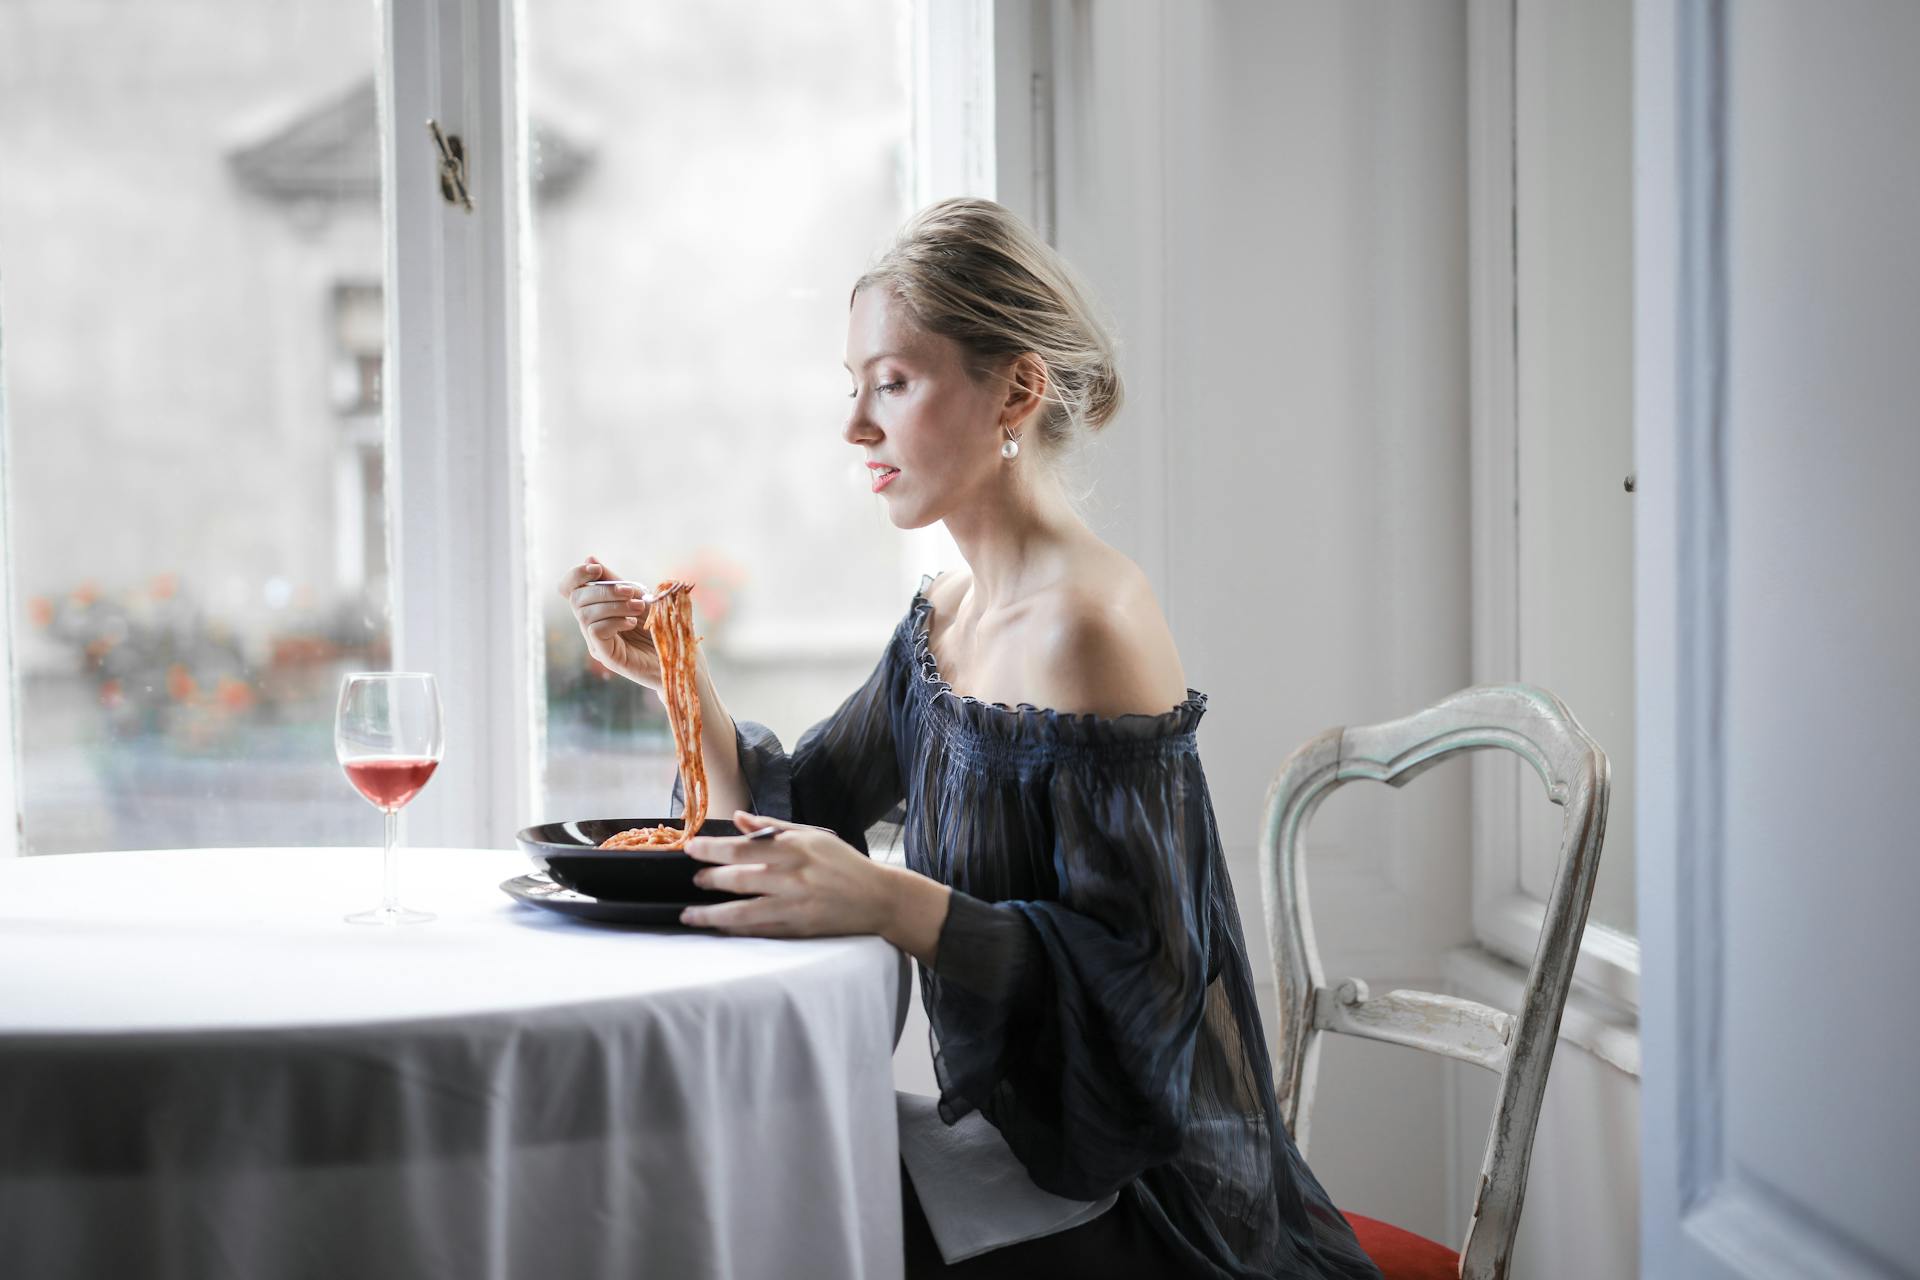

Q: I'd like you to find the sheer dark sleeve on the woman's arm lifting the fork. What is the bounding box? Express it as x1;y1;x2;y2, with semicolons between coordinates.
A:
668;645;902;854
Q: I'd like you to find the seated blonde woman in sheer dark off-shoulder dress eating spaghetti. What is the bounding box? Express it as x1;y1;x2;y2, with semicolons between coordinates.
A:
561;200;1379;1280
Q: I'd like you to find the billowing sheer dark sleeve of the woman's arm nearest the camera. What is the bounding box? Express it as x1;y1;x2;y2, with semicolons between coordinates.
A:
927;750;1217;1199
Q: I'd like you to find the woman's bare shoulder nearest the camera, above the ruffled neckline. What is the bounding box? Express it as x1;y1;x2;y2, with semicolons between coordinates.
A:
1027;551;1187;716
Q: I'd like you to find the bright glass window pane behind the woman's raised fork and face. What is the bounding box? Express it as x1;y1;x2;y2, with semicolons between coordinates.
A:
526;0;914;818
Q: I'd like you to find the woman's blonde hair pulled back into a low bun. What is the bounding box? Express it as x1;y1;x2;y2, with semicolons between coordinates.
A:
849;198;1121;455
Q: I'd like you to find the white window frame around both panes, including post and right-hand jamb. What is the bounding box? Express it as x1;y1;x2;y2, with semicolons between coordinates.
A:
0;0;1006;858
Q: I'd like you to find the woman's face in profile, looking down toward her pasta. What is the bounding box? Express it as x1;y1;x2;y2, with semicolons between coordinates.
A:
841;288;1006;530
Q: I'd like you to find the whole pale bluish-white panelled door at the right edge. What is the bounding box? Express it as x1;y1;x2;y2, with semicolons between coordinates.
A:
1634;0;1920;1280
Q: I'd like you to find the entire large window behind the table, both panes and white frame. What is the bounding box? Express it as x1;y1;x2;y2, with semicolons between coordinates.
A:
0;0;993;854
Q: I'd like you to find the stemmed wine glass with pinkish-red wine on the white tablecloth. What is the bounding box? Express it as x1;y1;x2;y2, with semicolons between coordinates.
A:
334;672;445;925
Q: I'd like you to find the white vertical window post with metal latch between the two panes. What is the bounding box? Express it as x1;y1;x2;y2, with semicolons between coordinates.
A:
380;0;541;848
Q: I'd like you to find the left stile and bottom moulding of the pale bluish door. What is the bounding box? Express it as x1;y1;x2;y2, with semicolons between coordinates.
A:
1634;0;1891;1280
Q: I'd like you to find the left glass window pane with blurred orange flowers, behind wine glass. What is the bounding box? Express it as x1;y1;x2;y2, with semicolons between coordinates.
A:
0;0;388;854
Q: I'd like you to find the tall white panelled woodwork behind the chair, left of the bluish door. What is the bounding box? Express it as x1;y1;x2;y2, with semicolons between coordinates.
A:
1467;0;1640;1007
